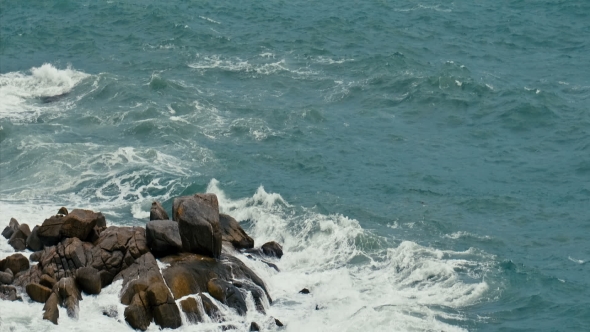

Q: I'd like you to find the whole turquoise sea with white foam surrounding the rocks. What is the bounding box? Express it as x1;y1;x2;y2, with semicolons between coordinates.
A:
0;0;590;331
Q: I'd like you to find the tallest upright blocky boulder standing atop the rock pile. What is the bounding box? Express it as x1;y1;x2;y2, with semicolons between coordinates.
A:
172;194;221;258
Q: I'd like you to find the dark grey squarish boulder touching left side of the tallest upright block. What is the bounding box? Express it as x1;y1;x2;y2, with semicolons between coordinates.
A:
145;220;182;257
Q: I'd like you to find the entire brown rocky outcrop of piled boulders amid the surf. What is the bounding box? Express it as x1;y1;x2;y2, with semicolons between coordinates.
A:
0;194;283;331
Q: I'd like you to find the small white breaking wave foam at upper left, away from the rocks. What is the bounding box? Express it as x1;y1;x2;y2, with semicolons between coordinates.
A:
0;63;90;121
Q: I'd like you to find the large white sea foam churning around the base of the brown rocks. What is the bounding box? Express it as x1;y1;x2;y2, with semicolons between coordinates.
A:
0;180;494;331
